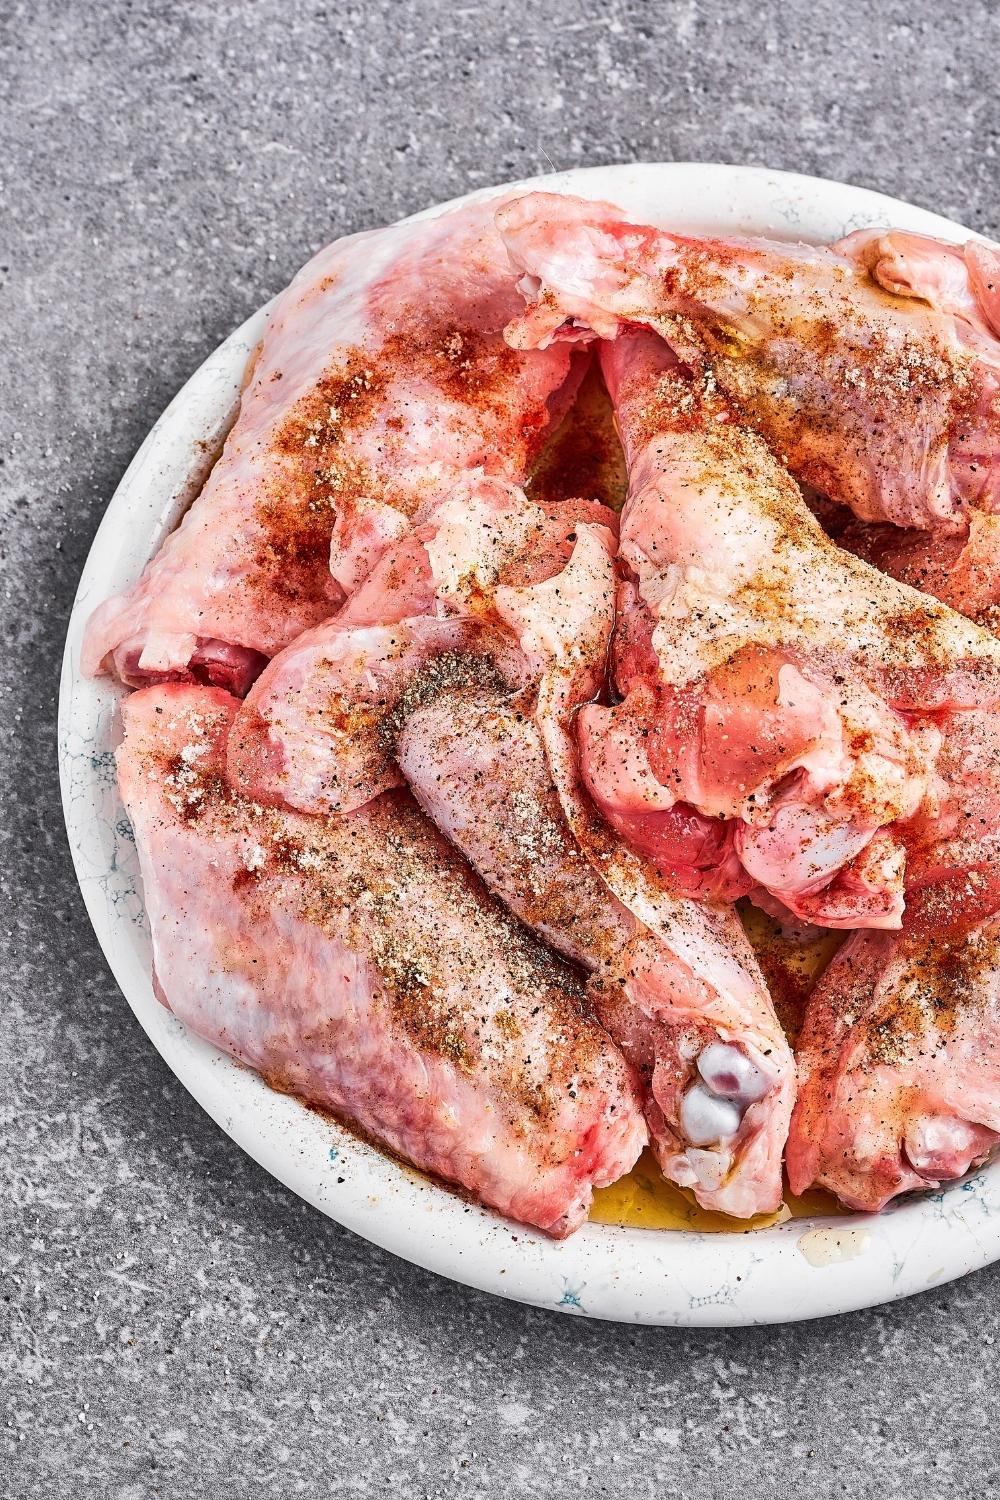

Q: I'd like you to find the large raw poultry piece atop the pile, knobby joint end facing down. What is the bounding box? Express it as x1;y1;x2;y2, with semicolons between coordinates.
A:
560;330;1000;927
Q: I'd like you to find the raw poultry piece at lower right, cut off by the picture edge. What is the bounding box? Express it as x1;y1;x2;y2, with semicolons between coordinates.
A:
787;875;1000;1211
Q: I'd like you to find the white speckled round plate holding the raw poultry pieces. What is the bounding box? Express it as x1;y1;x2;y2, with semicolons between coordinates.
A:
58;164;1000;1325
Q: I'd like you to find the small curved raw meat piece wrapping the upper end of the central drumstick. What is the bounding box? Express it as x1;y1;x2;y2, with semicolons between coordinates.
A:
229;479;615;813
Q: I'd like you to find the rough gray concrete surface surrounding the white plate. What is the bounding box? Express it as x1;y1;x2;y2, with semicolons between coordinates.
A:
0;0;1000;1500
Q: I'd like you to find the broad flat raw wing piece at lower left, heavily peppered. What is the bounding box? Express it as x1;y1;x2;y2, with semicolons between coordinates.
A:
118;684;646;1236
